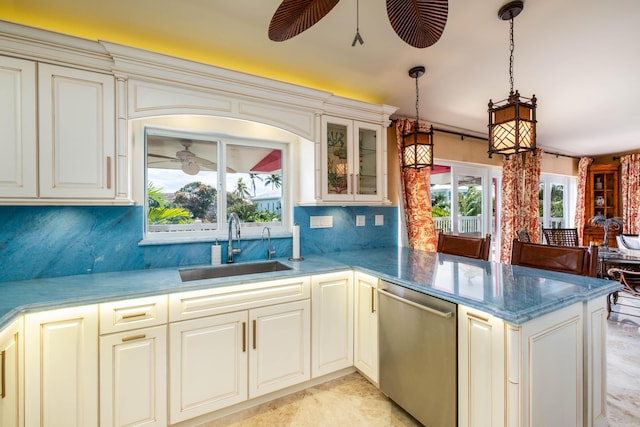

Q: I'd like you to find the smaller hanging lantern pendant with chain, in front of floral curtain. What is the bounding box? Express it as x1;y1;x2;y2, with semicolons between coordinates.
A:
402;65;433;169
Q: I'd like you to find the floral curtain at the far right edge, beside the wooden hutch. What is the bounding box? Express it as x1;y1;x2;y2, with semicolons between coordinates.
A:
620;154;640;234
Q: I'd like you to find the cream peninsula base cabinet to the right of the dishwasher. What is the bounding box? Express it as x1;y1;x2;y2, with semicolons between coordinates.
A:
458;299;607;427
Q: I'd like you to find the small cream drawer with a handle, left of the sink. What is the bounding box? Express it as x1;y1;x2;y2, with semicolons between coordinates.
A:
100;295;168;335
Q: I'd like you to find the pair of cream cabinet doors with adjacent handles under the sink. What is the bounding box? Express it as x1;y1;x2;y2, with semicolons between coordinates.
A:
169;299;311;424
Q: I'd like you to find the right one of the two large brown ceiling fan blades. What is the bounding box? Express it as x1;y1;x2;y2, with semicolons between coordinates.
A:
387;0;449;48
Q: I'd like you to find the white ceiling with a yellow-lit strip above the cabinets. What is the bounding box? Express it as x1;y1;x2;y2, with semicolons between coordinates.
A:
5;0;640;156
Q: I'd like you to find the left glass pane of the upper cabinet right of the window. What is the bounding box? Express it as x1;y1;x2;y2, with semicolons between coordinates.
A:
327;123;349;194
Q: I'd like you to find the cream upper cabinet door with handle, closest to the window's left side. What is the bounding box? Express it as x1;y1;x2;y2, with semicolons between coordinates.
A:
38;64;115;199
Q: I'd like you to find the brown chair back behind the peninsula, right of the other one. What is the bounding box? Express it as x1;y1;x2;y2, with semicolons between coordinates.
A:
511;239;598;277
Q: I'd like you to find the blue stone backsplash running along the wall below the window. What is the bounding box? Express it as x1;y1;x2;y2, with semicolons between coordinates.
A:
0;206;398;282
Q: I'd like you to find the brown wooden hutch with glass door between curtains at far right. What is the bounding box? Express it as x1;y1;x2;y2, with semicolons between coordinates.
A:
582;164;622;248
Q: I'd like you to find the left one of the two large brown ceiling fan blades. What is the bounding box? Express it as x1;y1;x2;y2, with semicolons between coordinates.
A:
269;0;339;42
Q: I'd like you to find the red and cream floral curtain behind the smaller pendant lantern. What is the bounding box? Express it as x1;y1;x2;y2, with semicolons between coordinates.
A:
396;119;438;252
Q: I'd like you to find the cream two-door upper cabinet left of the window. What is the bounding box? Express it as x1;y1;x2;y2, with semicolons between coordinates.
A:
0;56;116;204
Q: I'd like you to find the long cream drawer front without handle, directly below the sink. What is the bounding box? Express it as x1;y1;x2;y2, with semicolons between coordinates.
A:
169;276;311;322
